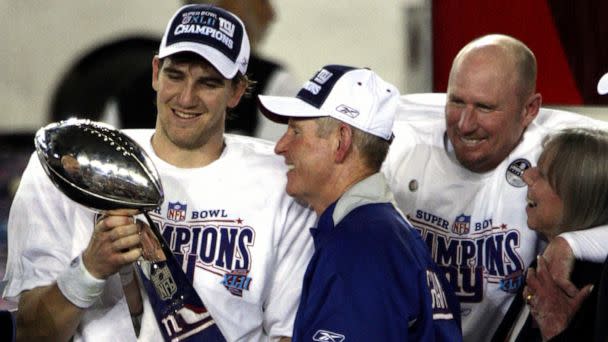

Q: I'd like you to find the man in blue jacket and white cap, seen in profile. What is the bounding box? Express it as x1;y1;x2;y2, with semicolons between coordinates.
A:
259;65;461;341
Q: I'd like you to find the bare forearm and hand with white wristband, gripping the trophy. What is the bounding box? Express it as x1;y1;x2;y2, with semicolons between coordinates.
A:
17;212;141;341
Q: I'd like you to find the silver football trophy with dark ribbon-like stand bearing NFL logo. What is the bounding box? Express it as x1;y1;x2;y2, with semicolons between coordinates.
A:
35;119;225;341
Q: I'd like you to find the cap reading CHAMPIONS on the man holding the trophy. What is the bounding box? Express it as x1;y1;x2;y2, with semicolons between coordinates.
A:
158;5;250;79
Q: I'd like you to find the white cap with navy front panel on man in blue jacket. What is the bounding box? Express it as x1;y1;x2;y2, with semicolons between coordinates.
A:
258;65;399;140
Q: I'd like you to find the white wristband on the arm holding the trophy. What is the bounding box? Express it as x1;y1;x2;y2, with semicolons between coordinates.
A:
57;255;106;309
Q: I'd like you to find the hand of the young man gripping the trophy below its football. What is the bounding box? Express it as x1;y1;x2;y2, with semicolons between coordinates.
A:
82;209;142;279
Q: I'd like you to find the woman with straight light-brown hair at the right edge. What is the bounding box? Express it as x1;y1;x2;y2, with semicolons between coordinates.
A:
493;128;608;341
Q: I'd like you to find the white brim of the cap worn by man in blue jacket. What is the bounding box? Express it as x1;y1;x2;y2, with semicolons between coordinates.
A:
258;95;329;124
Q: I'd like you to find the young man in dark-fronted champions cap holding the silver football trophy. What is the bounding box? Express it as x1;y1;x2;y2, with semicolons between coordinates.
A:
3;5;315;341
